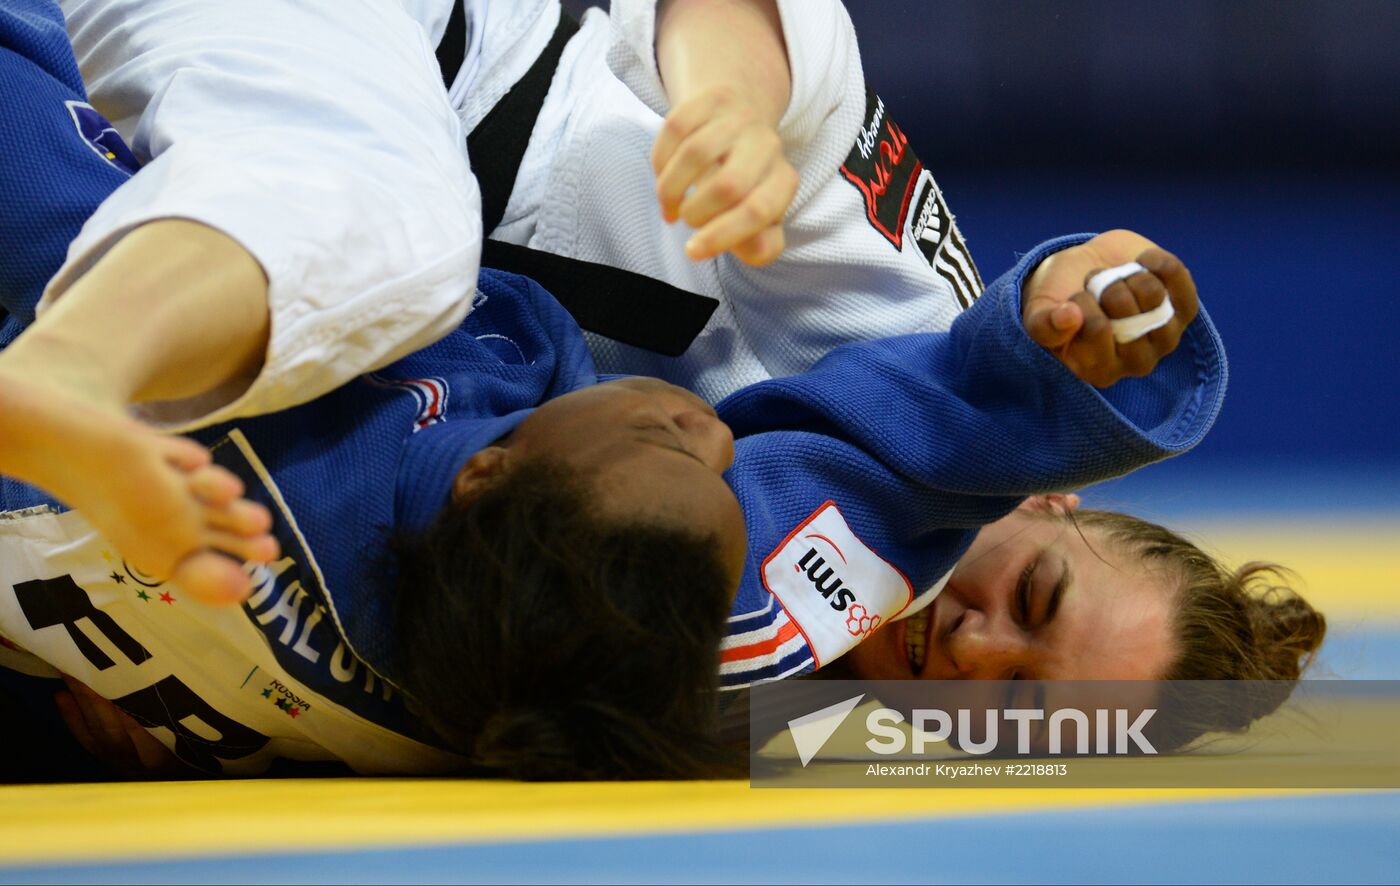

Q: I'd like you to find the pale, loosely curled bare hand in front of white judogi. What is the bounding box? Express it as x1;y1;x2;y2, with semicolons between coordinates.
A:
651;87;798;265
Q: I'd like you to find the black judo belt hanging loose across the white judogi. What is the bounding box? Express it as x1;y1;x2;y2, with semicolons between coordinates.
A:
437;6;720;357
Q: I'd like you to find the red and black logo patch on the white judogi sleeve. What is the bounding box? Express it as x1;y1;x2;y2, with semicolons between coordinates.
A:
841;88;923;249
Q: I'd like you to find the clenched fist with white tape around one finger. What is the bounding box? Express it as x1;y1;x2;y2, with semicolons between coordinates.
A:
1021;231;1200;388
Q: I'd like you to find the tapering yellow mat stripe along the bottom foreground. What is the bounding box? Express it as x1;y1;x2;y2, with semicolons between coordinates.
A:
0;780;1338;865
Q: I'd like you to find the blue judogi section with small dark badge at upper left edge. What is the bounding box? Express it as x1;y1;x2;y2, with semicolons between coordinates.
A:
0;0;137;326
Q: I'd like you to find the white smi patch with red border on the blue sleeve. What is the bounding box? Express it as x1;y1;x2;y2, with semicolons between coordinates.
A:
762;501;914;668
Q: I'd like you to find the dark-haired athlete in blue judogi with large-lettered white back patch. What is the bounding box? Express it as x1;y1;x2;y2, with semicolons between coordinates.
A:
0;4;1225;777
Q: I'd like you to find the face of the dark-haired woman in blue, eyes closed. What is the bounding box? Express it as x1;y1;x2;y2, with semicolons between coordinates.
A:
487;378;748;588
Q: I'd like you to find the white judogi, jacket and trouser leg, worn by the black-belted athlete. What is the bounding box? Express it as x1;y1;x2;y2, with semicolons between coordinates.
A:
60;0;980;414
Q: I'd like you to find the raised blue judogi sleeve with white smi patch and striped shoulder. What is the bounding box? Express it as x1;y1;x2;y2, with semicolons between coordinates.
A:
718;235;1226;686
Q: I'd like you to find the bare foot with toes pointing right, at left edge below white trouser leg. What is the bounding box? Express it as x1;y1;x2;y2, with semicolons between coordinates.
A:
0;372;277;605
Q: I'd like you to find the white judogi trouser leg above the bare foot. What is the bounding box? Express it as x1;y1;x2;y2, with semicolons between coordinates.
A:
53;0;482;428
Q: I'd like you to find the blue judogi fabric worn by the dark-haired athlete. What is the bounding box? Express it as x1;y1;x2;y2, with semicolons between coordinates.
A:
0;0;1226;761
